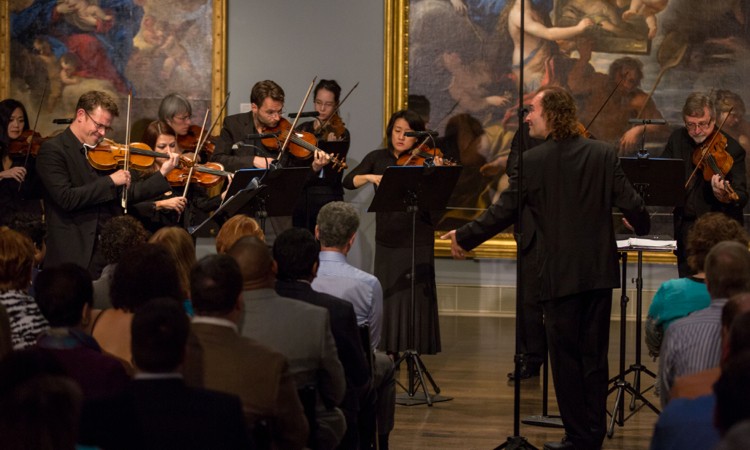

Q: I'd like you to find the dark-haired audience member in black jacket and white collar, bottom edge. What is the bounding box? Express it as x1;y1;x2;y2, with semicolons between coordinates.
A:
80;298;251;450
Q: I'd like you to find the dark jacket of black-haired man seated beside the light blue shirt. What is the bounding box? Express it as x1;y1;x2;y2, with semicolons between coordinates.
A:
276;281;370;402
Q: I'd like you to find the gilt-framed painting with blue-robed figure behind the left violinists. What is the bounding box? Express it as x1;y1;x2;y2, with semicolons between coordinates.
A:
3;0;226;139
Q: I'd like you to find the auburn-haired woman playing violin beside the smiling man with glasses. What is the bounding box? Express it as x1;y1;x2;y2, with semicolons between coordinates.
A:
133;120;223;232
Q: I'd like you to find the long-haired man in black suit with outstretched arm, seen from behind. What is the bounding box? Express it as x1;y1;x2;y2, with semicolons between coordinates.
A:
443;87;650;449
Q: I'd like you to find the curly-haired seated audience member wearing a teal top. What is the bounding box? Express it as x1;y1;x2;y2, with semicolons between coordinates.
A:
646;212;748;356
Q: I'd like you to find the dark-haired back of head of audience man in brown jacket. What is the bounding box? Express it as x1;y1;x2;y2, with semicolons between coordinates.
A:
190;255;242;316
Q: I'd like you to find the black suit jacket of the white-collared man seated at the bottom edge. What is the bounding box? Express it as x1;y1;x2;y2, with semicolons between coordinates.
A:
79;378;250;450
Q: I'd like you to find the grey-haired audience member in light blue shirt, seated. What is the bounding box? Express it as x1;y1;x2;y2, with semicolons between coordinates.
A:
312;202;396;450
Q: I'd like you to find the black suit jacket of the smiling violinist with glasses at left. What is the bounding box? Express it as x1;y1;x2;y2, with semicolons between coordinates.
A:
36;128;171;268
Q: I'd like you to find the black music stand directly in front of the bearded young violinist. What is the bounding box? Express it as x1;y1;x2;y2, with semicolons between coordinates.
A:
227;167;310;233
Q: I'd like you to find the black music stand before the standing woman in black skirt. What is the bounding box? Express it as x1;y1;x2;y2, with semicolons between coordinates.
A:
367;166;462;406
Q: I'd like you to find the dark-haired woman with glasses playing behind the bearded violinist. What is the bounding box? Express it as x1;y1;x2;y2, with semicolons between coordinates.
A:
292;80;350;232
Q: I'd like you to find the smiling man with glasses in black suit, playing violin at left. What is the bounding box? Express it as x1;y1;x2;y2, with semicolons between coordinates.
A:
36;91;178;279
